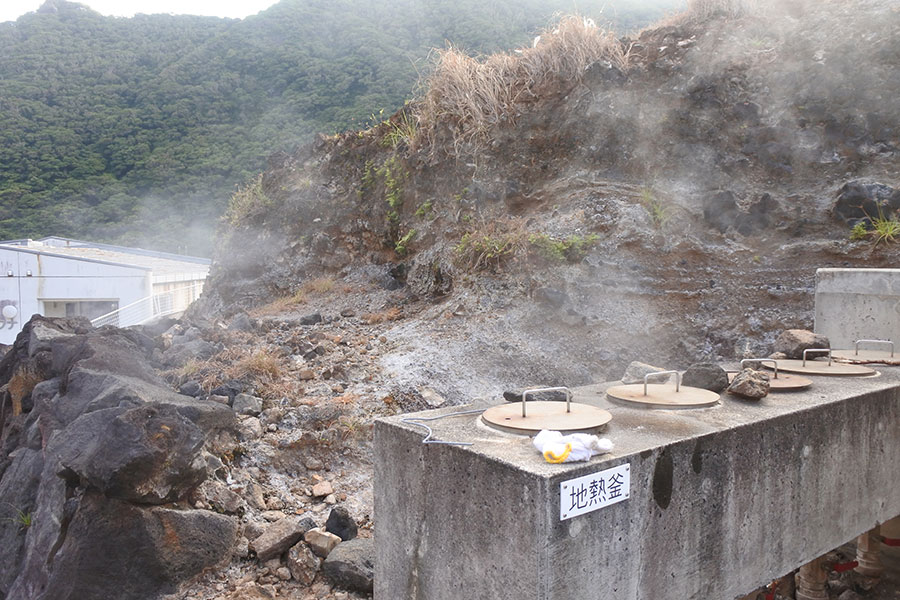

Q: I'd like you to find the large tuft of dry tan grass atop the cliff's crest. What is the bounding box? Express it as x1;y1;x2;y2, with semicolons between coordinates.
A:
416;16;628;151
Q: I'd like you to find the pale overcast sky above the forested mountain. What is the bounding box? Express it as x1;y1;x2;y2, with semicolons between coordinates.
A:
0;0;278;23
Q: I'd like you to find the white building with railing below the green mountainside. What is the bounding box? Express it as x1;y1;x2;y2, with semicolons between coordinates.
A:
0;237;210;344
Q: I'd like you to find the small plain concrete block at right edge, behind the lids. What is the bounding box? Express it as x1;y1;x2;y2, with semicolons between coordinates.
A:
815;269;900;350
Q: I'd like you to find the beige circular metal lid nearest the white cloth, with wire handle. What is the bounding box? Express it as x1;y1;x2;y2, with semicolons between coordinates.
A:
481;401;612;434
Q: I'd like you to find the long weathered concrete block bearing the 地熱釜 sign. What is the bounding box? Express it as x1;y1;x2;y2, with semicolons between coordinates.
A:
375;367;900;600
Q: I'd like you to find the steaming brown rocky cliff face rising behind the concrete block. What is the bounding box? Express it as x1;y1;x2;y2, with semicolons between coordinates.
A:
199;0;900;400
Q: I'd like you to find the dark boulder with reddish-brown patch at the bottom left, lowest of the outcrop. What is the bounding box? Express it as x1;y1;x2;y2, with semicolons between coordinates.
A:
7;492;237;600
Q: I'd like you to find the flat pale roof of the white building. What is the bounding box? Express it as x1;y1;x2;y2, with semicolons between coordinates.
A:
0;237;210;275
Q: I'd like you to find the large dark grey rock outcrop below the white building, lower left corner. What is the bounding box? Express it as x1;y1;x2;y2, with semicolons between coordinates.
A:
0;317;238;600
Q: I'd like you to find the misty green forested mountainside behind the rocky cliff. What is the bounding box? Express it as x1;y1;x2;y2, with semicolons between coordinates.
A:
0;0;679;253
